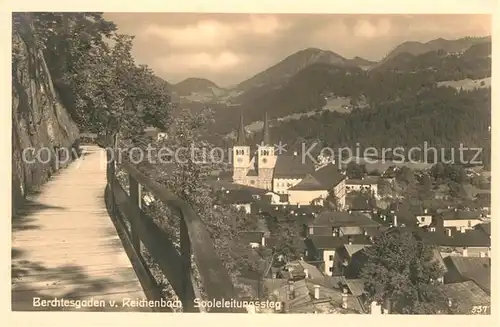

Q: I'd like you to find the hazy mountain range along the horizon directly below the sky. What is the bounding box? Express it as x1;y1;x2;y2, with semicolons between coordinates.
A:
157;37;491;147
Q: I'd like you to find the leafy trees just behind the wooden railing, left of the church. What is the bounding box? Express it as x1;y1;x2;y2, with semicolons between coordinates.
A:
139;110;264;283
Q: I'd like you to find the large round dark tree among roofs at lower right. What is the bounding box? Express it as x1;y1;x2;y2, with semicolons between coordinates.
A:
361;230;447;314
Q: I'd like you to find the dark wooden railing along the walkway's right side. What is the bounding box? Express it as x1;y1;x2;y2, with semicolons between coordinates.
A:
106;152;241;312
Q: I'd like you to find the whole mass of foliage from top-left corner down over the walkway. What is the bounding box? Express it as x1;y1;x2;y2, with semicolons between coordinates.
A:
23;13;172;146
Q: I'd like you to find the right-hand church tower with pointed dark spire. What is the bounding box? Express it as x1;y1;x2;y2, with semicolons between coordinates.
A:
257;112;276;190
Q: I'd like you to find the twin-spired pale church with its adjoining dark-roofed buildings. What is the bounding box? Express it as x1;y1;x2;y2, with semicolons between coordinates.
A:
232;113;345;207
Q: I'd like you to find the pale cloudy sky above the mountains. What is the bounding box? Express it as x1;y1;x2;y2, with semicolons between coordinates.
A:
104;13;491;87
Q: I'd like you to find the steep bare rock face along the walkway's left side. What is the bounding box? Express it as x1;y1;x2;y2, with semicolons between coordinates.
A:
12;26;79;214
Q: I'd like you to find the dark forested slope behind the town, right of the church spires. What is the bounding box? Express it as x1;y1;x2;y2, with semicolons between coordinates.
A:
272;88;491;148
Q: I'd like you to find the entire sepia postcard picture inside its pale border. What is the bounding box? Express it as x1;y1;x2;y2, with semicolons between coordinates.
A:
5;1;496;324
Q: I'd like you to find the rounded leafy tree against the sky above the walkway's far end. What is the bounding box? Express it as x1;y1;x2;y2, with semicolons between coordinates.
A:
69;35;172;145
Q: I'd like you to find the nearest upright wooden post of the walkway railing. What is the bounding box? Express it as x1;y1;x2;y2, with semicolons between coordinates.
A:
180;218;195;312
